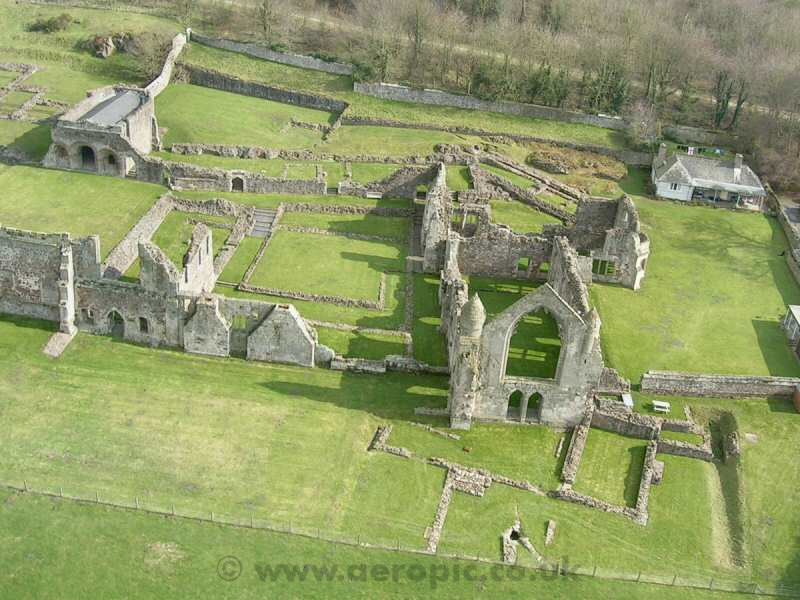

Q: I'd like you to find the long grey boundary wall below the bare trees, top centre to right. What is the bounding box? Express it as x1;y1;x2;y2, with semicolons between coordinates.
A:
353;82;627;130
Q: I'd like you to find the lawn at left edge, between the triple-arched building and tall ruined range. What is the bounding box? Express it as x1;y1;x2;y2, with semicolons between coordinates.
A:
0;165;164;256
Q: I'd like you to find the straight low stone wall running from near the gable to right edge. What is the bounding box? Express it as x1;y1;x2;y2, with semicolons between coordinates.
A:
641;371;800;398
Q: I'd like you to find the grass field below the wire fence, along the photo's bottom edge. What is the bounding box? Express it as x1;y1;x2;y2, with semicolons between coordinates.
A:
0;492;742;600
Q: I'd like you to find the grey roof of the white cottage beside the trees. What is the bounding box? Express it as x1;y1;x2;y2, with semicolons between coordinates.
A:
655;154;766;196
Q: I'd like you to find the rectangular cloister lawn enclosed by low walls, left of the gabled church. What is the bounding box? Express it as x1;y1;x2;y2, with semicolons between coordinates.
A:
250;231;405;302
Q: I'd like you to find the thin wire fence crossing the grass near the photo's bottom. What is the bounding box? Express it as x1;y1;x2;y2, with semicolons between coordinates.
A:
0;481;800;598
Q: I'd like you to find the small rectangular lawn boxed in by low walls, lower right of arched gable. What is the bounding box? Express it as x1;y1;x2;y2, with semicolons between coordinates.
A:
575;429;647;507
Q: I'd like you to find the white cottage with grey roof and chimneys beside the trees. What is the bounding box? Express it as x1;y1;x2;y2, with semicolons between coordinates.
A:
651;144;767;210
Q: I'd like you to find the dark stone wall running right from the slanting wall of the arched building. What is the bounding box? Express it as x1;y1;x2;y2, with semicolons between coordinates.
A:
181;65;347;113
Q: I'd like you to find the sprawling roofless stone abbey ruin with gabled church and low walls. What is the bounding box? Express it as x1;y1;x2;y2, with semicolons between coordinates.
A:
0;23;764;552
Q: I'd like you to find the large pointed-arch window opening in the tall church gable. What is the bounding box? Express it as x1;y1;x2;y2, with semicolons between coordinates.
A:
506;309;561;379
